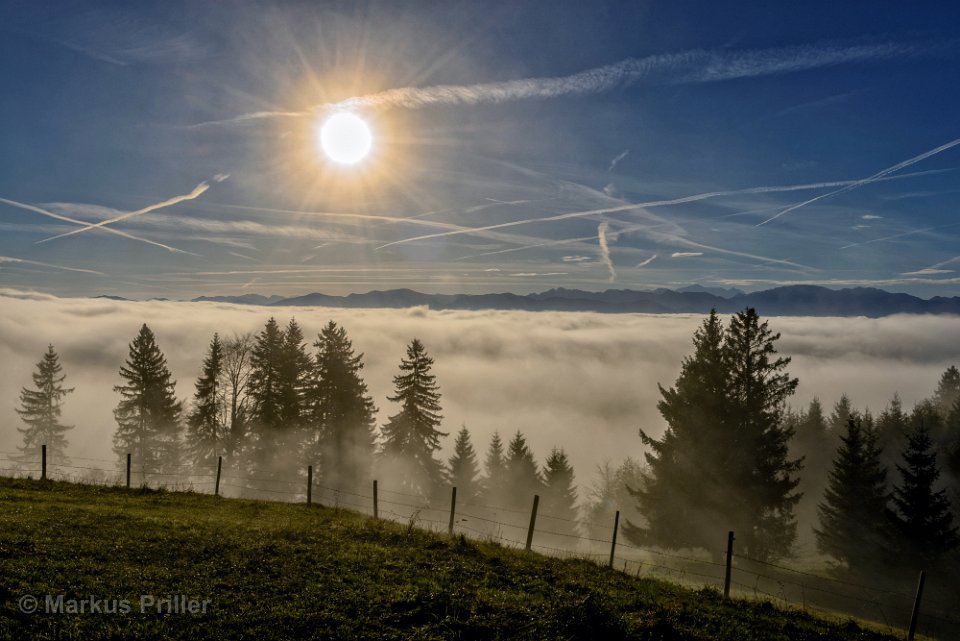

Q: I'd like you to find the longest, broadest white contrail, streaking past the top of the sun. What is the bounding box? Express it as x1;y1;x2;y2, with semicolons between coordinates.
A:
188;43;932;128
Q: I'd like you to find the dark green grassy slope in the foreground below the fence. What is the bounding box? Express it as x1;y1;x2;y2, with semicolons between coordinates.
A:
0;479;895;641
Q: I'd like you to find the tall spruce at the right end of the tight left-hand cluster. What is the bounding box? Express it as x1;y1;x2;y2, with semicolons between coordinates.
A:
307;321;377;490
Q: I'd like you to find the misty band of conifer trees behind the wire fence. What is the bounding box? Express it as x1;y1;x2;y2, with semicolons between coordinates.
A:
9;309;960;575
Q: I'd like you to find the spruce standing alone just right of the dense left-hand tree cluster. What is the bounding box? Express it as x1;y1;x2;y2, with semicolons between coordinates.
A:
382;339;447;496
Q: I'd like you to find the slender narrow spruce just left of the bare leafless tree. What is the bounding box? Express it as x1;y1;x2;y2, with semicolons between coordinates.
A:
186;334;227;465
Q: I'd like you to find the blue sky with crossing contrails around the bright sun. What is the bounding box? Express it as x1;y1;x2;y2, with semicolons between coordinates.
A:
0;1;960;298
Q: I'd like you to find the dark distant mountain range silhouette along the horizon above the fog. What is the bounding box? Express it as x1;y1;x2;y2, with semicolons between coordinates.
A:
186;285;960;318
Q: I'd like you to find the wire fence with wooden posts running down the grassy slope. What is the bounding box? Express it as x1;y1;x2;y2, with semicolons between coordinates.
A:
0;451;960;639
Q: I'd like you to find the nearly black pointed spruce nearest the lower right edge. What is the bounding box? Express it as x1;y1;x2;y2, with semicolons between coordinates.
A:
893;424;960;565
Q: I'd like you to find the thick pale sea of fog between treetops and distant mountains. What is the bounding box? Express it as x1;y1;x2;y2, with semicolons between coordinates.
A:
0;290;960;492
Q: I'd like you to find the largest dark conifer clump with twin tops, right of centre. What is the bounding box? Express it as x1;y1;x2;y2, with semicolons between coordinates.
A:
624;309;800;560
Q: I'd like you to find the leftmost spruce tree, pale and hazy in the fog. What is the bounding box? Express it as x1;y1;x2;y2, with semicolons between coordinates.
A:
16;345;74;466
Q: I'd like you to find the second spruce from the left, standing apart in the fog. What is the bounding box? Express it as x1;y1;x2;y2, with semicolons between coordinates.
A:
113;324;182;483
